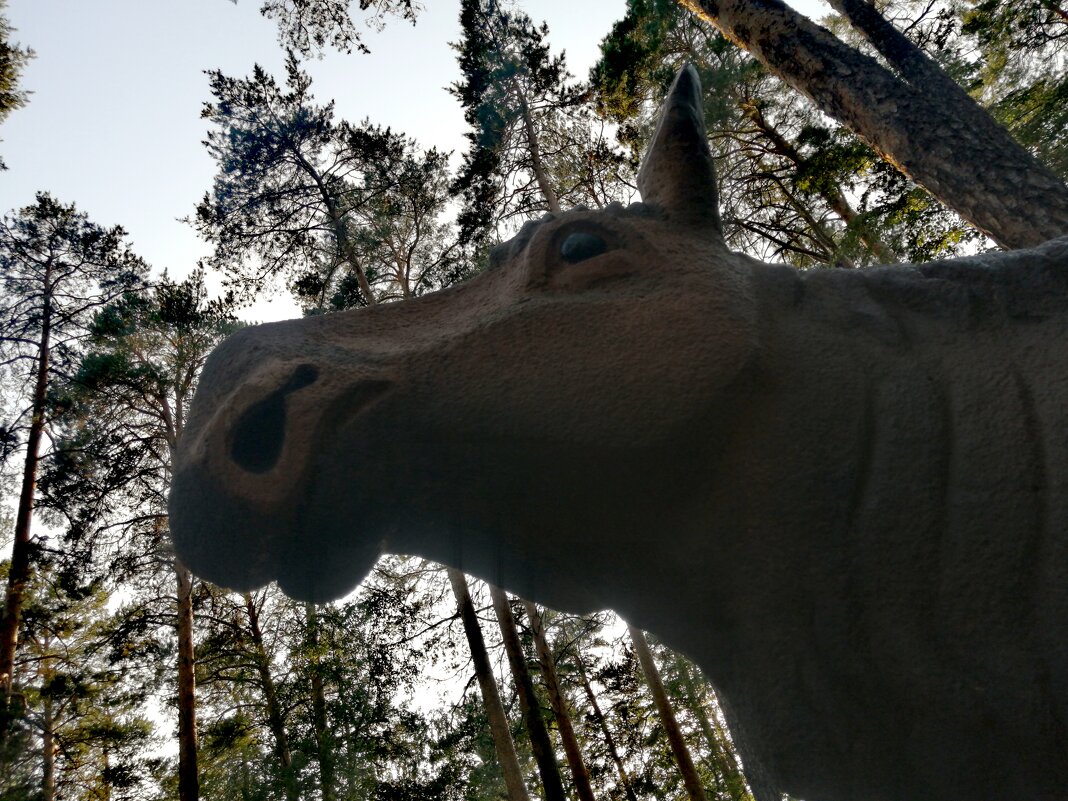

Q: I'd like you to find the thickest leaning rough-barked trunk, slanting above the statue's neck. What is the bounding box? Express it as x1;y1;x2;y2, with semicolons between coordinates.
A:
679;0;1068;248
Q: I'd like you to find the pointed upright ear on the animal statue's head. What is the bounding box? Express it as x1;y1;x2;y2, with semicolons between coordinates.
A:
638;64;722;237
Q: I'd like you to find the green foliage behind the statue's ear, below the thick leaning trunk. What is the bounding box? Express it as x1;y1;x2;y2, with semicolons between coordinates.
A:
591;0;975;267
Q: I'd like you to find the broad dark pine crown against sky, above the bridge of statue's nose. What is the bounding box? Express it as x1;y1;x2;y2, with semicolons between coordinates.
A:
193;52;466;312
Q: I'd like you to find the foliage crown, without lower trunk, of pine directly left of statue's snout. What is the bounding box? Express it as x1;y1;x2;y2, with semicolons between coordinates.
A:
40;270;237;580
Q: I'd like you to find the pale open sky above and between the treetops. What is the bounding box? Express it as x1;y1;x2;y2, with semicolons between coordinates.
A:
0;0;822;320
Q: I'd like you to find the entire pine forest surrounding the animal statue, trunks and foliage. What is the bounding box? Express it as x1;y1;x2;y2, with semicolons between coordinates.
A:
0;0;1068;801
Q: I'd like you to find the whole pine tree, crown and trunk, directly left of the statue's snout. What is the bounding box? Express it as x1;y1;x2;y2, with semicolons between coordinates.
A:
49;271;236;801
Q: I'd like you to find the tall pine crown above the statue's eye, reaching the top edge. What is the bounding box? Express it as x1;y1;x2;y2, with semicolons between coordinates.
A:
450;0;631;247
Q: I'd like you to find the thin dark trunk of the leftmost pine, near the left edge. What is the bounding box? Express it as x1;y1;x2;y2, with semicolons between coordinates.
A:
0;275;52;713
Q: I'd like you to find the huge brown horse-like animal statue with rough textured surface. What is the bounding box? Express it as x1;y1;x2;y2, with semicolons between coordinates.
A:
171;70;1068;801
